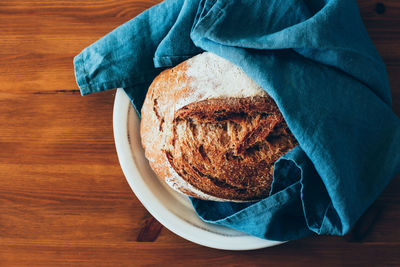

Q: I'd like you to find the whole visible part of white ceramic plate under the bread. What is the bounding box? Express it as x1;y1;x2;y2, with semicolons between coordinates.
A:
113;89;282;250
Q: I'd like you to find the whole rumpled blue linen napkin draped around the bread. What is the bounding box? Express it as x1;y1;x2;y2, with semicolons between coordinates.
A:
74;0;400;243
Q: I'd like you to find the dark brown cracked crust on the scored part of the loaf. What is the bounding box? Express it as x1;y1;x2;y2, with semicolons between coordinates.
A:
166;97;296;200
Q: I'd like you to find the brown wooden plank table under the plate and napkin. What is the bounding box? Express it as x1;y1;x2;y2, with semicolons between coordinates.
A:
0;0;400;266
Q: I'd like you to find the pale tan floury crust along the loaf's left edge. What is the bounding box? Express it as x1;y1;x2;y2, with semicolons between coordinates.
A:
140;58;206;197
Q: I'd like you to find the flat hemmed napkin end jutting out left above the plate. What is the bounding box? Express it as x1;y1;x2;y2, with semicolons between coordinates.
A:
74;0;185;95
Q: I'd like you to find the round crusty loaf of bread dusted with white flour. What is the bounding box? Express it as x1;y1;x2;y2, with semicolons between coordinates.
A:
140;52;297;201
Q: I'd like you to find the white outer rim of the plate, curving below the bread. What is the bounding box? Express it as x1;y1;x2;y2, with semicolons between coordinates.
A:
113;88;285;250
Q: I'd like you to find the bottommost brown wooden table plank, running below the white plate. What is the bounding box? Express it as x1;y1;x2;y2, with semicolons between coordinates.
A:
0;238;400;266
